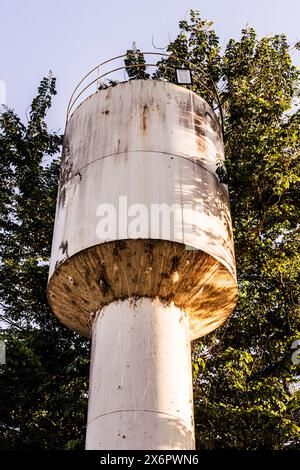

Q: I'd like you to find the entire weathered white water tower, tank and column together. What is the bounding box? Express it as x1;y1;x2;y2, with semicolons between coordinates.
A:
48;54;237;449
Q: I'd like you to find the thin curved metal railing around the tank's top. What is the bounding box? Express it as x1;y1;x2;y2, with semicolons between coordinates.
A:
66;51;224;136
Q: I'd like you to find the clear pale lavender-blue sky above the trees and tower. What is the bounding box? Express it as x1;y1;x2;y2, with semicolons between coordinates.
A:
0;0;300;130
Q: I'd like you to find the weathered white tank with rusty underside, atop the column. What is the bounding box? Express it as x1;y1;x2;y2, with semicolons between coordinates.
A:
48;80;237;339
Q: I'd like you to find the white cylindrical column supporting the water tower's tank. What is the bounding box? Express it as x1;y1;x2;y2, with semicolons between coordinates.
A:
86;298;194;450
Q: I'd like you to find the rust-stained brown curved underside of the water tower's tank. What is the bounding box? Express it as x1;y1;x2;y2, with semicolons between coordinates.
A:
48;239;237;339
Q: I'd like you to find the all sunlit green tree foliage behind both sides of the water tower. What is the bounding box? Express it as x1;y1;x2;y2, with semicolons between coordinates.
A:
0;11;300;449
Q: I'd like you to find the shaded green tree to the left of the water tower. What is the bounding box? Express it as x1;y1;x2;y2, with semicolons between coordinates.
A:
0;75;88;449
